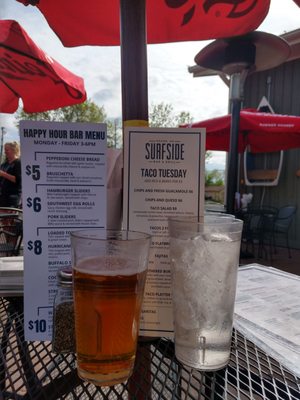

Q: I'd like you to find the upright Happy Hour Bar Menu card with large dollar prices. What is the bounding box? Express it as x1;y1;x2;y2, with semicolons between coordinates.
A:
20;121;106;340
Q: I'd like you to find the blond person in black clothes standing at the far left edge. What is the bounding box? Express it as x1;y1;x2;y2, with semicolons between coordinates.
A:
0;142;22;208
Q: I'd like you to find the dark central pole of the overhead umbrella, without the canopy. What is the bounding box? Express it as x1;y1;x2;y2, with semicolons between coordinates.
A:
120;0;151;400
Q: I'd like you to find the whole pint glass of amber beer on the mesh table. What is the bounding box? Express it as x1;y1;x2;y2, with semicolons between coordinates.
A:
71;229;151;386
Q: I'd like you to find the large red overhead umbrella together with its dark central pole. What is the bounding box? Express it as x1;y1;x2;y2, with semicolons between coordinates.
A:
17;0;270;125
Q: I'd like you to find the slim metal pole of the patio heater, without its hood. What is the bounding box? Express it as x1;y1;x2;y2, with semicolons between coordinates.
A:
226;70;248;214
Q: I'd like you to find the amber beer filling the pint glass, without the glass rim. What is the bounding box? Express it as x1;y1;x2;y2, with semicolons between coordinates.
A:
74;258;146;385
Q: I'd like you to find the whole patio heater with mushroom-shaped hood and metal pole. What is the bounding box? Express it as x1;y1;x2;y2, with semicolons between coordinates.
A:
195;31;290;214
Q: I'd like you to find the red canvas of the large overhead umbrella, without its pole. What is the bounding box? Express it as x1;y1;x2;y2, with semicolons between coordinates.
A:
17;0;270;47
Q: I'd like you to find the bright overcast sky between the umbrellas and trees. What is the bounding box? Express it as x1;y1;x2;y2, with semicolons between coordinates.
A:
0;0;300;168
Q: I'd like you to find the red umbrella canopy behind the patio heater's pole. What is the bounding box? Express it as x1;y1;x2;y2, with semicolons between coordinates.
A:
185;109;300;153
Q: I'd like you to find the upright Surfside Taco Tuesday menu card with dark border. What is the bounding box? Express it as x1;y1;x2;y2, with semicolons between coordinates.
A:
123;128;205;338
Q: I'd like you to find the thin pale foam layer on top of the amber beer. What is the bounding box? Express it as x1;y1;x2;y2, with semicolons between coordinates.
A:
73;256;147;276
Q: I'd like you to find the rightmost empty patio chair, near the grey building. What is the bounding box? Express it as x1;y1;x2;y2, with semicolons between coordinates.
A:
270;205;297;258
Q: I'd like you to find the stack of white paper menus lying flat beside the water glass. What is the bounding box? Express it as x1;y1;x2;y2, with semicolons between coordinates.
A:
234;264;300;376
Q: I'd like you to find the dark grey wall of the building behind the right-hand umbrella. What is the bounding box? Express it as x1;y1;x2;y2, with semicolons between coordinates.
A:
241;59;300;249
